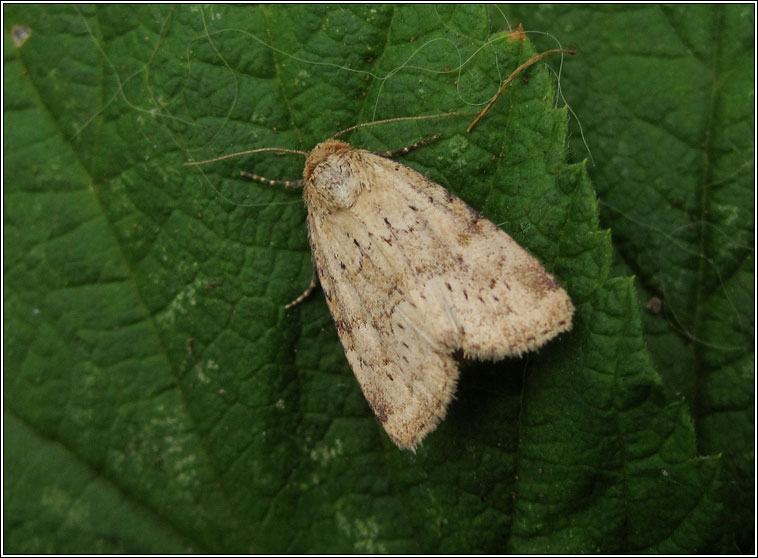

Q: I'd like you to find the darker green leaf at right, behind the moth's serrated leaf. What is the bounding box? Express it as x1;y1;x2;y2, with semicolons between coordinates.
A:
506;5;755;553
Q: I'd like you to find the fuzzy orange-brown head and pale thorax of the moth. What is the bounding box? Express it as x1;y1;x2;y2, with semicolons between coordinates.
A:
303;140;363;210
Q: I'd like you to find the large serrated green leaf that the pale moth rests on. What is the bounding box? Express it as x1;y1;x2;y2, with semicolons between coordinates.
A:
3;5;752;553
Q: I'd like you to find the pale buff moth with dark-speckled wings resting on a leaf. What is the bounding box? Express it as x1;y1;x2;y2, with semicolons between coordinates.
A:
294;140;574;450
